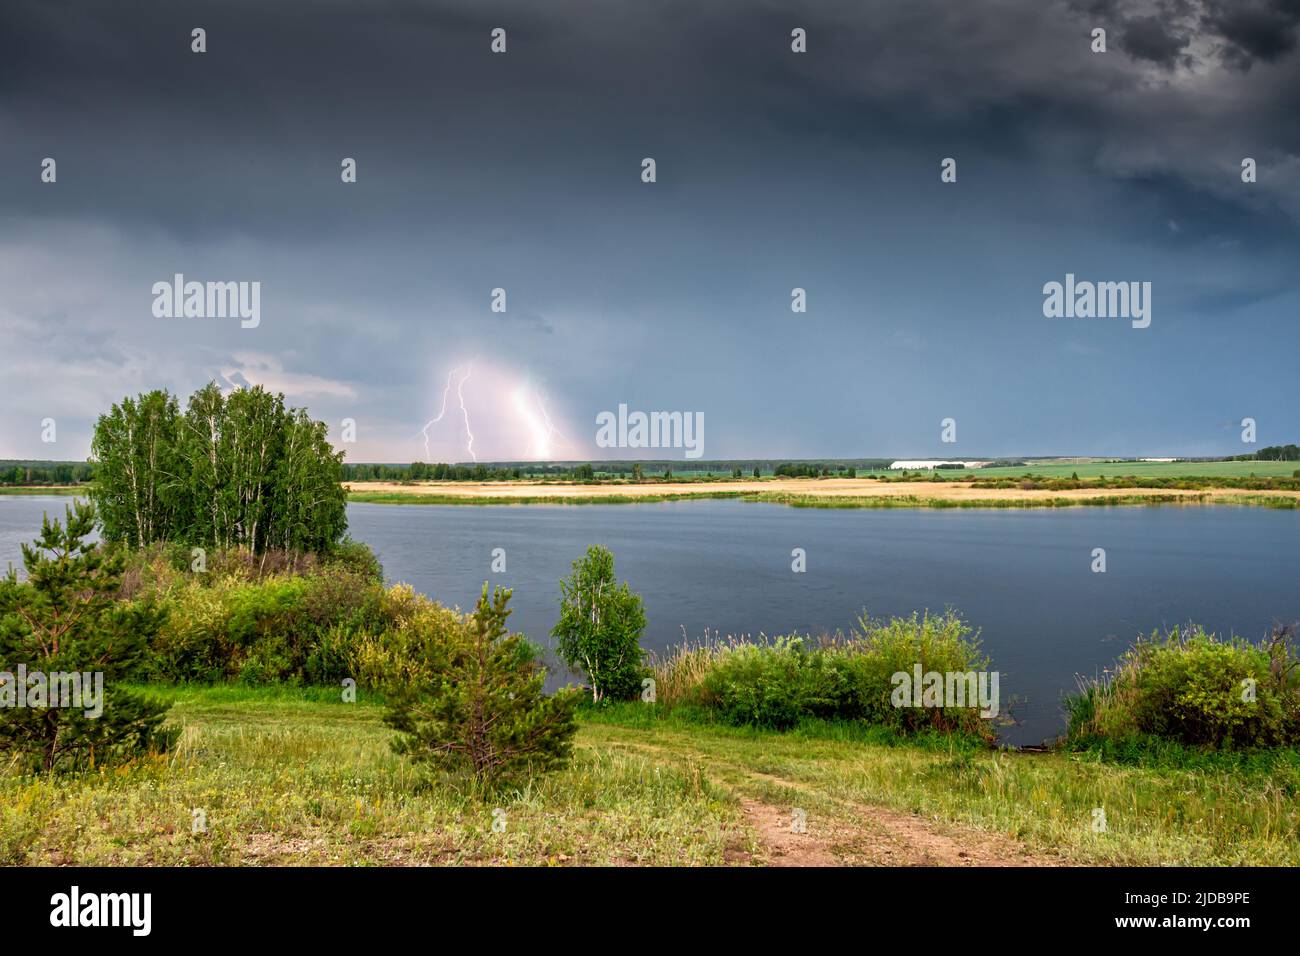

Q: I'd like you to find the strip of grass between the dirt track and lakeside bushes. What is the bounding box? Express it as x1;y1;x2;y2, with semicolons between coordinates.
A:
584;711;1300;866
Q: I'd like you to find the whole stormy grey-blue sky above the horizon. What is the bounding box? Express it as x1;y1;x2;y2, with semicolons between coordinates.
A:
0;0;1300;462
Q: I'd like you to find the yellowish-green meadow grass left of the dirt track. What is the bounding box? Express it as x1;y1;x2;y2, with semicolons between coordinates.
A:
0;688;741;865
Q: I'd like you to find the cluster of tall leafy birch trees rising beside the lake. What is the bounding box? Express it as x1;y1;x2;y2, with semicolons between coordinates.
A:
91;382;347;553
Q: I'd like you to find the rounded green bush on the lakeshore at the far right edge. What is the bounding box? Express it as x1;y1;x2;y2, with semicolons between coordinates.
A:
1066;624;1300;749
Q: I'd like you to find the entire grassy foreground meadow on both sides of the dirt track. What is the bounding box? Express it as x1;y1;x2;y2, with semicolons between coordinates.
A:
0;687;1300;865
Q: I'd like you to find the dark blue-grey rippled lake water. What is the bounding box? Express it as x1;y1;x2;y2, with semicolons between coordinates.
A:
0;497;1300;744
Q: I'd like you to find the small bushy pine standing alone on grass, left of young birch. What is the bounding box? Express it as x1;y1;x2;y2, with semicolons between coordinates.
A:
385;584;579;784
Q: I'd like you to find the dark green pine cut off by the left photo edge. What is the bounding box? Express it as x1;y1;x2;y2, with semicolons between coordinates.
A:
0;502;177;771
